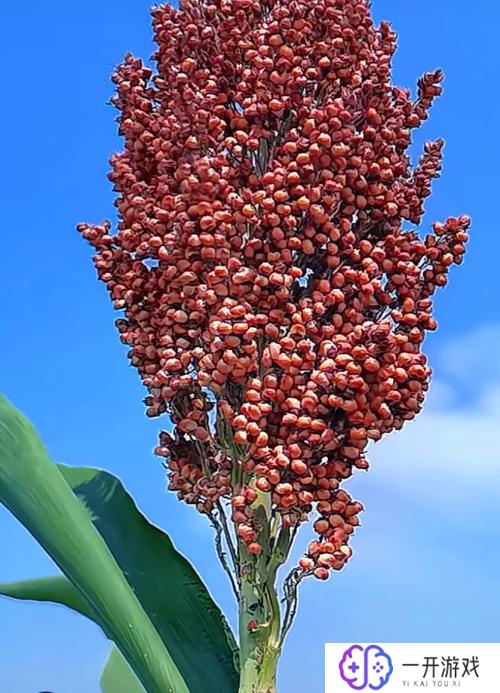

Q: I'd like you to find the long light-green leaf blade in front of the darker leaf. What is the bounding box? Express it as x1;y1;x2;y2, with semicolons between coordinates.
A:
0;397;189;693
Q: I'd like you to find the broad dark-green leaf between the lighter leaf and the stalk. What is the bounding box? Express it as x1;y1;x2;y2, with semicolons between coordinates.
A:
59;465;239;693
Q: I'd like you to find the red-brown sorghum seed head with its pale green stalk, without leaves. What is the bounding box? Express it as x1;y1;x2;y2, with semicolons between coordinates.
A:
79;0;469;693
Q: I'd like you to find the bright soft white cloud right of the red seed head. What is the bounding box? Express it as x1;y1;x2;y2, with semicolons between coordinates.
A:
351;325;500;508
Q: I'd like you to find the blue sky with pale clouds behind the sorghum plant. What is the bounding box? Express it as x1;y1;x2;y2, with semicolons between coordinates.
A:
0;0;500;693
